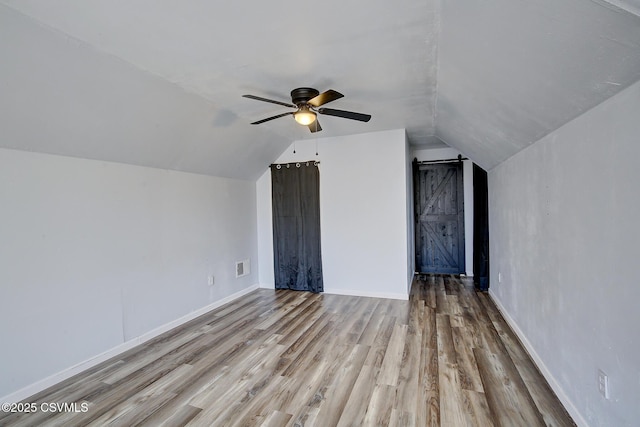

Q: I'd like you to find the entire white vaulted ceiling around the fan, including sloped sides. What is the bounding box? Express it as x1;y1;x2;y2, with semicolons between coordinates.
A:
0;0;640;179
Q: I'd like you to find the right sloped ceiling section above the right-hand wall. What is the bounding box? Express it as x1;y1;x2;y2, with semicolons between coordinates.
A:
436;0;640;168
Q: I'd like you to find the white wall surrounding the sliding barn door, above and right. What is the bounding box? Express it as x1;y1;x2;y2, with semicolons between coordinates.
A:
411;148;473;277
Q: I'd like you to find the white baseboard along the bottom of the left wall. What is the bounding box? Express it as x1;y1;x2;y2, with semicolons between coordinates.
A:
0;284;259;402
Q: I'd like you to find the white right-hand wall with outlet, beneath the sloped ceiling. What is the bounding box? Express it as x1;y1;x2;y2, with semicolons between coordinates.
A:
489;84;640;426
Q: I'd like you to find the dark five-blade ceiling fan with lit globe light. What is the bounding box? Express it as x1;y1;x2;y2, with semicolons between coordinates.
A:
242;87;371;132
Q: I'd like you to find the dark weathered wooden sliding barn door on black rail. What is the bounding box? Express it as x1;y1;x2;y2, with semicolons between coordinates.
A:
414;162;465;274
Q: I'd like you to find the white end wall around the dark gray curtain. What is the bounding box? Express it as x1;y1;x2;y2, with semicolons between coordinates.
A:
256;129;413;299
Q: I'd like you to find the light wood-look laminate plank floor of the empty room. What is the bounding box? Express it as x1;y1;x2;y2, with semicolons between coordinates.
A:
0;275;574;427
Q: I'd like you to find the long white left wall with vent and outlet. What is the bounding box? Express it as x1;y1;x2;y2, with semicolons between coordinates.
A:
0;149;257;396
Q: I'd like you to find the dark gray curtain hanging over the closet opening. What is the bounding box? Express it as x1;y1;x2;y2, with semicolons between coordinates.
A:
271;161;324;292
